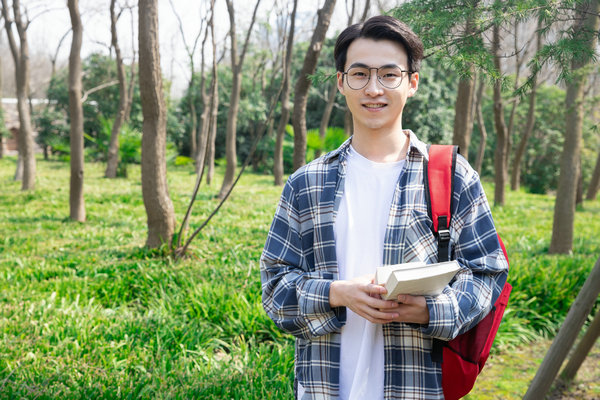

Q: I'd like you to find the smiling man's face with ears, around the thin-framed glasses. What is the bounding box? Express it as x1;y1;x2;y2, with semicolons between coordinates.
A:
337;38;419;134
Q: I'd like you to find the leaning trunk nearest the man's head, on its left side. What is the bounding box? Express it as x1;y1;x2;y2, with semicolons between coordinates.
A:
292;0;335;170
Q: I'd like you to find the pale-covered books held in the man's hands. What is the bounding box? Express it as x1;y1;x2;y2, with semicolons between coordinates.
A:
375;260;460;300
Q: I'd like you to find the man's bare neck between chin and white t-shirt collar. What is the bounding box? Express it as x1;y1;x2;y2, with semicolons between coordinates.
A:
352;129;410;163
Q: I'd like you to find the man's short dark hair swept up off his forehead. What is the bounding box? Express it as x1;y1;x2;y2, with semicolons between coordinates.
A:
333;15;423;72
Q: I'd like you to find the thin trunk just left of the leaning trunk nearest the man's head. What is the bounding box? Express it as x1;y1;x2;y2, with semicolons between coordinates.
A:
273;0;298;186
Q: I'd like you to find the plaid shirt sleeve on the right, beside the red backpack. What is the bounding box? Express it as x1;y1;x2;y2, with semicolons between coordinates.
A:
421;159;508;340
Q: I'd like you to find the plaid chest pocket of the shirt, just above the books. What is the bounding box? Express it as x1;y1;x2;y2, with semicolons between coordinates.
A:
402;209;437;264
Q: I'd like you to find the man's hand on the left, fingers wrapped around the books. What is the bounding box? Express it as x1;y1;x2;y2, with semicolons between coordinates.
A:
329;275;398;324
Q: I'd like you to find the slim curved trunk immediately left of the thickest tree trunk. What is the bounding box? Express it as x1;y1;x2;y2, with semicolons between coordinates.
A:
104;0;129;178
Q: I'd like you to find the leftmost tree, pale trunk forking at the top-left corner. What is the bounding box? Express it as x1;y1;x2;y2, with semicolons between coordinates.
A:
2;0;36;190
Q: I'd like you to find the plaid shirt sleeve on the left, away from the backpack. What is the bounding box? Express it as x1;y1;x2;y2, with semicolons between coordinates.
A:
260;181;345;339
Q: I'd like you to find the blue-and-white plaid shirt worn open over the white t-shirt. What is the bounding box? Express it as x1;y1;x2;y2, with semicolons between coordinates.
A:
260;131;508;400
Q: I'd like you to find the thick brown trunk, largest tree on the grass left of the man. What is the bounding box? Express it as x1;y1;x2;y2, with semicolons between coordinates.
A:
138;0;175;248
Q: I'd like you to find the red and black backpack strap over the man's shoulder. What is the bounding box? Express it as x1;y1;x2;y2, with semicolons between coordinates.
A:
423;145;459;262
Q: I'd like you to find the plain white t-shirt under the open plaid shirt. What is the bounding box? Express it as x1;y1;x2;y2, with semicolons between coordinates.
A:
334;147;404;400
